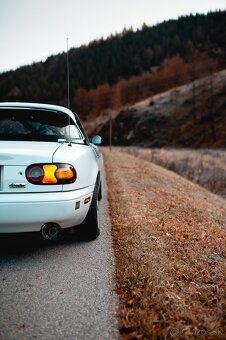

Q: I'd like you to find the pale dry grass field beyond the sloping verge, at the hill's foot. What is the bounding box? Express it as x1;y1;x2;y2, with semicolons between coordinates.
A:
119;147;226;197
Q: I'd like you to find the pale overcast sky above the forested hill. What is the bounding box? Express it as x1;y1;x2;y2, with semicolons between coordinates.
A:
0;0;226;72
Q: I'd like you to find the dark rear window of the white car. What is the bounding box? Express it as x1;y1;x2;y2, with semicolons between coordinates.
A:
0;108;83;141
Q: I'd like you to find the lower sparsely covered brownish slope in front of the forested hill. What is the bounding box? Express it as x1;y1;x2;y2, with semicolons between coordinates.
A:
98;70;226;148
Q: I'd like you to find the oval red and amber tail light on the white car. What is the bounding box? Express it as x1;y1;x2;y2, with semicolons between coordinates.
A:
26;163;77;185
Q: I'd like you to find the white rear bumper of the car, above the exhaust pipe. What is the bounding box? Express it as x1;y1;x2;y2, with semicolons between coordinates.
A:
0;186;94;233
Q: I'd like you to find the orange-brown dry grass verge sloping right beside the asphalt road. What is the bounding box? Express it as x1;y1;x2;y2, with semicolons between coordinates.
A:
103;149;226;339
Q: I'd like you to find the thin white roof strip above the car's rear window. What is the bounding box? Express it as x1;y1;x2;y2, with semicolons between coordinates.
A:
0;102;74;118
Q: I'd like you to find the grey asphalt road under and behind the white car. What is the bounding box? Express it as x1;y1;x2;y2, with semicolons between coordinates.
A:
0;173;118;340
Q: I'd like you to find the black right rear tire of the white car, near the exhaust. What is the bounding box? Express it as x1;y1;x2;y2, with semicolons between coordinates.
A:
77;185;100;241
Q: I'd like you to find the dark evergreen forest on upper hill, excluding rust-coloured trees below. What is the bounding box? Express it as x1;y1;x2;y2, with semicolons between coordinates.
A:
0;11;226;115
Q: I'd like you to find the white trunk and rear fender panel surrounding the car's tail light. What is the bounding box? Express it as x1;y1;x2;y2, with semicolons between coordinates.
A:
0;141;99;194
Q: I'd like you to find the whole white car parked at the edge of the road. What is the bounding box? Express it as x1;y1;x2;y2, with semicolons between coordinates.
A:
0;103;102;240
